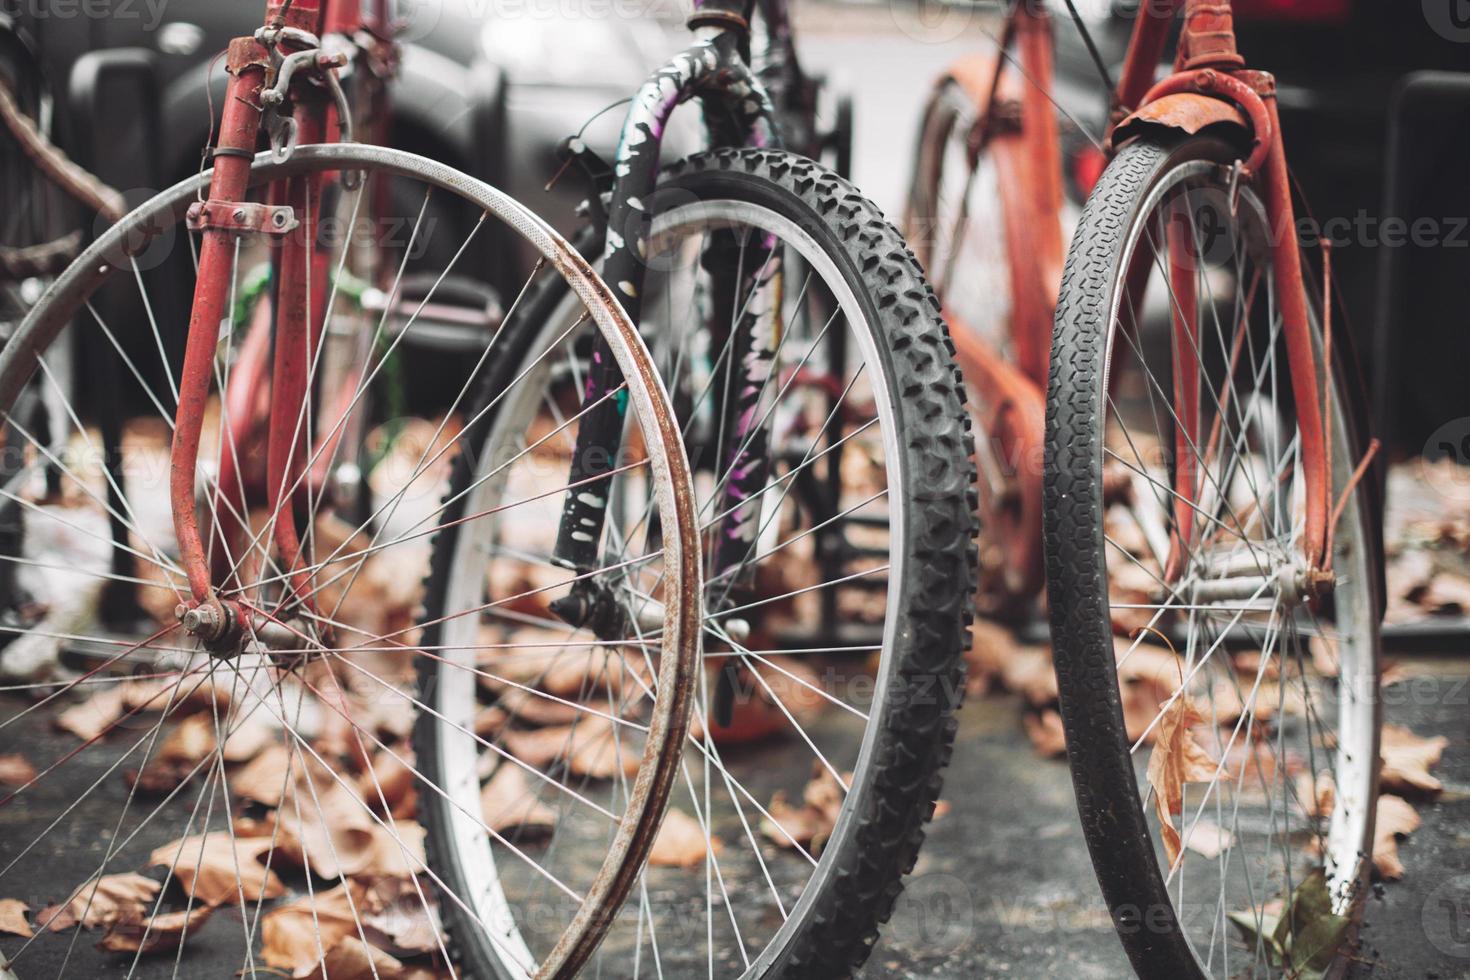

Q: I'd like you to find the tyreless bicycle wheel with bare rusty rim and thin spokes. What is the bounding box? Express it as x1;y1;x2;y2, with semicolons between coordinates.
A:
0;144;698;977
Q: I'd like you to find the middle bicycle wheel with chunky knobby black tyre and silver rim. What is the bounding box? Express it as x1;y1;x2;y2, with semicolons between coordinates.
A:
431;151;973;977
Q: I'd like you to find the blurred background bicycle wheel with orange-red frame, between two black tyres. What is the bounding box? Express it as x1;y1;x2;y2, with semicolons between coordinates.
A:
906;71;1070;616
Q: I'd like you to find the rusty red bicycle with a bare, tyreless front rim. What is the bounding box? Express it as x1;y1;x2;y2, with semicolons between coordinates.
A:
0;0;700;976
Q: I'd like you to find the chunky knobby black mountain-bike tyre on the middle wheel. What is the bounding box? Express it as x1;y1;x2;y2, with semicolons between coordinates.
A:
416;150;976;980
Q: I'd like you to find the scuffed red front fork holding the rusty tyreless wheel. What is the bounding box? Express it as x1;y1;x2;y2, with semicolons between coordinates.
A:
169;0;390;642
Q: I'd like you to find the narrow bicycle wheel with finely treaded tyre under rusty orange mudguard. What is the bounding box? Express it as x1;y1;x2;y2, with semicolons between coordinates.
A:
1045;138;1382;977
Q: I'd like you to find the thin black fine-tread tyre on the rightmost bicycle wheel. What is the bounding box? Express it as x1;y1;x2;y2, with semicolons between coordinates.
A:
1044;134;1382;980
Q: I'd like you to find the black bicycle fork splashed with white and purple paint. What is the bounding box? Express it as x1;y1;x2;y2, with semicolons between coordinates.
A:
551;28;781;696
